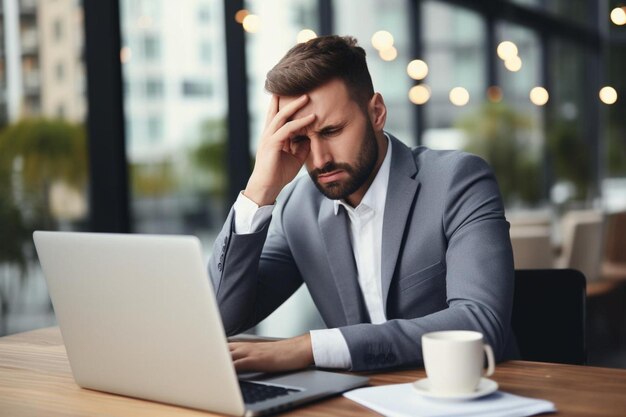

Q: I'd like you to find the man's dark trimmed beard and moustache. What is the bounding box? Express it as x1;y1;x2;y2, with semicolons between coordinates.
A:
309;120;378;200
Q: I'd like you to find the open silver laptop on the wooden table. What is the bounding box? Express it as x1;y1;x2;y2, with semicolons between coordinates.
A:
34;231;368;416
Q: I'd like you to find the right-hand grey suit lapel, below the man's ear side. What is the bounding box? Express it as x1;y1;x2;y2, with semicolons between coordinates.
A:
381;135;419;311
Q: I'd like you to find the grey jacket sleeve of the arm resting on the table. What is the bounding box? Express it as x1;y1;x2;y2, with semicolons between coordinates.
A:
340;153;514;371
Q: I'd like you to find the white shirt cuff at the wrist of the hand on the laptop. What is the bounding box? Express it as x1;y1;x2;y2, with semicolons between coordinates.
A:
309;329;352;369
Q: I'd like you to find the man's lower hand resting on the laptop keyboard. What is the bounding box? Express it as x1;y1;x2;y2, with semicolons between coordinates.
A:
228;333;313;372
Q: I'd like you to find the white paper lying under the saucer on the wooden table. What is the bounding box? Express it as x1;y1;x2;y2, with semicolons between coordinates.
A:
343;384;556;417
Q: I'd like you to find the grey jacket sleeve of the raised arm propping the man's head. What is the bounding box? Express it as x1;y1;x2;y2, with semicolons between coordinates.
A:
208;185;302;335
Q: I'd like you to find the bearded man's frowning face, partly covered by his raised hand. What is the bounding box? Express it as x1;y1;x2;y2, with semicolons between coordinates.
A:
279;79;379;204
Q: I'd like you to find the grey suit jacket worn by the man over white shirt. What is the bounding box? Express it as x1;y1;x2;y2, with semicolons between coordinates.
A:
209;135;513;370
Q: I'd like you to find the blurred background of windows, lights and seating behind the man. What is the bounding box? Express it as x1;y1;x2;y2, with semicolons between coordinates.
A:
0;0;626;367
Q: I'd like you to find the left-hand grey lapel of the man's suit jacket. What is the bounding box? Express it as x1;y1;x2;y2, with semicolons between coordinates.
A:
318;198;369;324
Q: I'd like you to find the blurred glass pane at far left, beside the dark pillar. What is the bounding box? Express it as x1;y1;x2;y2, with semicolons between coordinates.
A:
0;0;89;335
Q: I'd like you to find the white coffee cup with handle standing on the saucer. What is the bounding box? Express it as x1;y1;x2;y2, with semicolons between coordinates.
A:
422;330;495;395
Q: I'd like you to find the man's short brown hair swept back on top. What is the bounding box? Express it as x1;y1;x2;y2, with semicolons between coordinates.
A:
265;35;374;106
